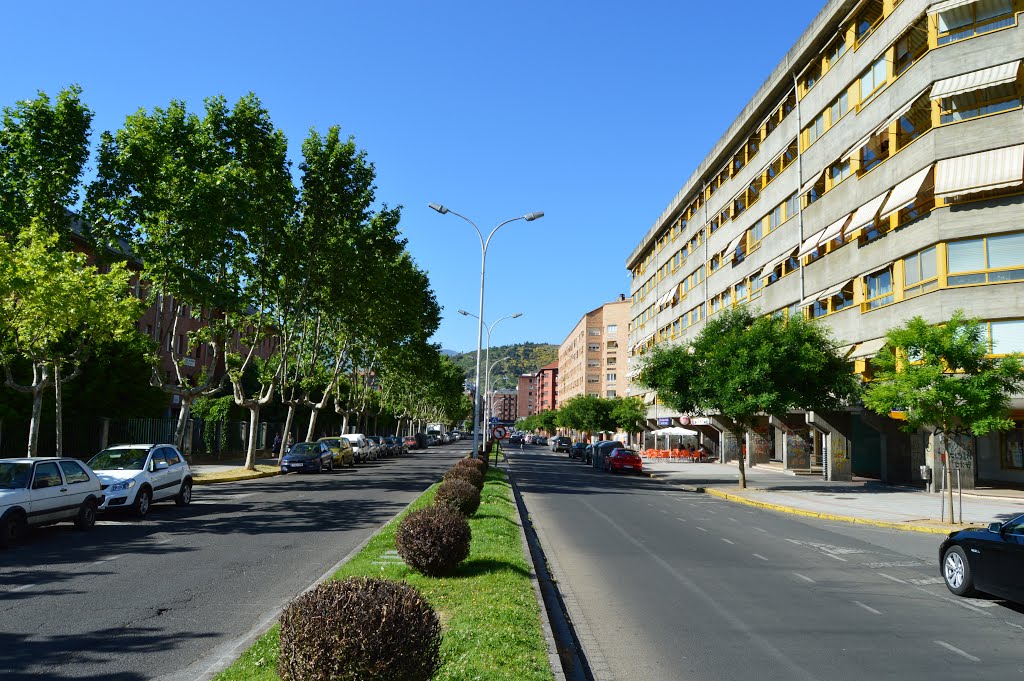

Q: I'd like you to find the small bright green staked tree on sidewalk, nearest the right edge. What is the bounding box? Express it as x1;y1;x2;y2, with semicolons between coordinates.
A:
864;310;1024;518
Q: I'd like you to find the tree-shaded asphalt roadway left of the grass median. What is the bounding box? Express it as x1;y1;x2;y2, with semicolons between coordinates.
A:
0;442;470;681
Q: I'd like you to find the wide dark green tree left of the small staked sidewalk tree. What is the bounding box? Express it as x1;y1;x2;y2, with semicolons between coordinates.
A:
638;307;858;487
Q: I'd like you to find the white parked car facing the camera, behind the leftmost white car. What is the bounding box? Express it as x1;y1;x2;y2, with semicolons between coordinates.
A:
89;444;193;518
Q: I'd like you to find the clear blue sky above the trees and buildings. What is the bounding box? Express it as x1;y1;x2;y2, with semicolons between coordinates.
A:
0;0;824;350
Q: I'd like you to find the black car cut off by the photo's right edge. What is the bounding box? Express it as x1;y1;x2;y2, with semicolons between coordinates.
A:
939;514;1024;603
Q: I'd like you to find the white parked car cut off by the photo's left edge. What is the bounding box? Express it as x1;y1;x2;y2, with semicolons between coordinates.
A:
0;457;103;547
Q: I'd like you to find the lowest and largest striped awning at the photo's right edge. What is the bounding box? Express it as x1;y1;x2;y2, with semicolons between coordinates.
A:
935;144;1024;199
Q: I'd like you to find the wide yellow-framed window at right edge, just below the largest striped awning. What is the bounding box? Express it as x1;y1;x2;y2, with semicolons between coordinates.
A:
946;232;1024;286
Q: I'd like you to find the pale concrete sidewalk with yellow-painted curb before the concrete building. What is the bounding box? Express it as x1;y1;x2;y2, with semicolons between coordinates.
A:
644;461;1024;534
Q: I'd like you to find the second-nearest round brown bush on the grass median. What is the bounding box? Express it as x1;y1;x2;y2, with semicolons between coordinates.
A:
394;504;472;577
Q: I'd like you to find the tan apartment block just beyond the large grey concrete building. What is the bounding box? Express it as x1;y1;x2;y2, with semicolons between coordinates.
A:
558;295;633;403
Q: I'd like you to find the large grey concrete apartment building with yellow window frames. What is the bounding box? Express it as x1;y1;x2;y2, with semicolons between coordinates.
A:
622;0;1024;485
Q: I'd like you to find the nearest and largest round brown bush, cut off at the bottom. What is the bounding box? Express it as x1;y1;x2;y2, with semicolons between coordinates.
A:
278;577;441;681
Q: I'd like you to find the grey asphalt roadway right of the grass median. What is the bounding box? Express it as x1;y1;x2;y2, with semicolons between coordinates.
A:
508;448;1024;681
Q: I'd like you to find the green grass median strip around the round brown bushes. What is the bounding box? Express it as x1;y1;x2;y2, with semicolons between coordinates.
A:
216;468;554;681
